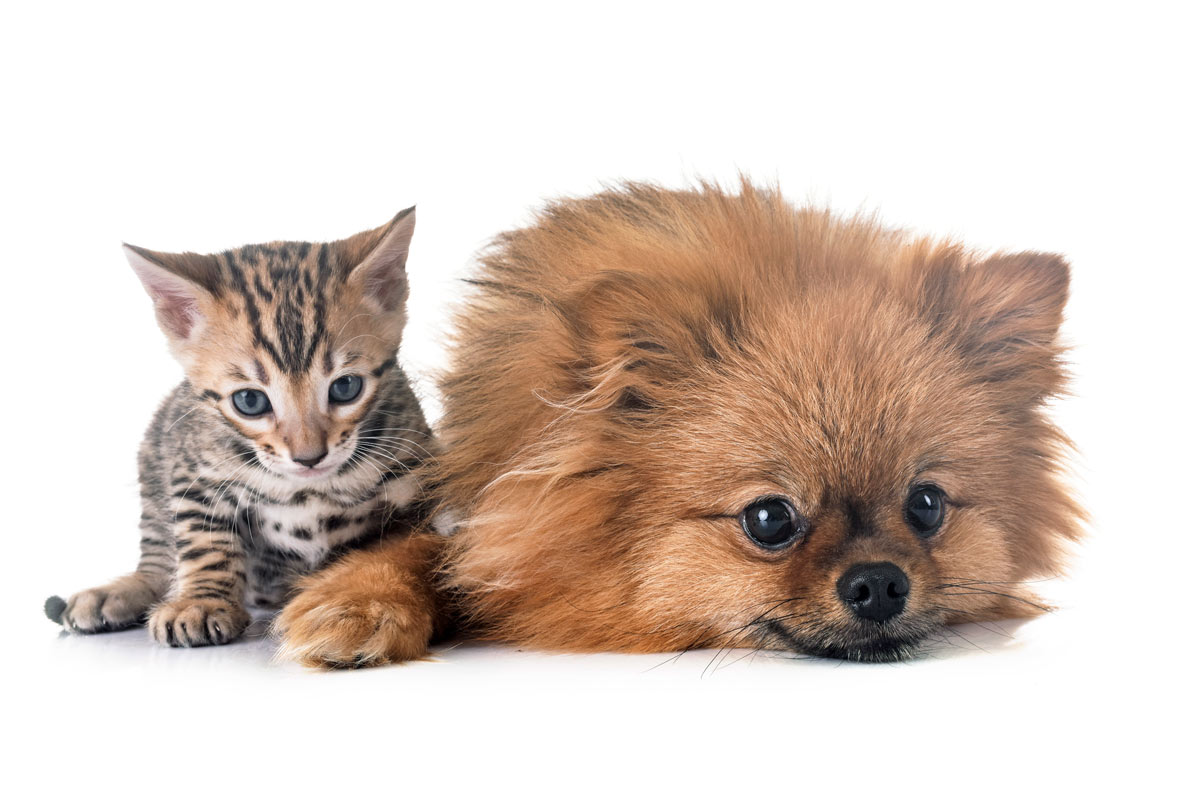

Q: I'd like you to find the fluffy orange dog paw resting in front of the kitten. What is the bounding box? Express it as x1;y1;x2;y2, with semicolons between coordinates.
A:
274;574;433;669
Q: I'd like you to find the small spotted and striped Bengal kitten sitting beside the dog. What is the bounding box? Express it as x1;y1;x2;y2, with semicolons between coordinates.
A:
46;209;431;646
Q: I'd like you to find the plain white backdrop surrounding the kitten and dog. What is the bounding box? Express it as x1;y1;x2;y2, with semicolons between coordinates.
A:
0;2;1200;790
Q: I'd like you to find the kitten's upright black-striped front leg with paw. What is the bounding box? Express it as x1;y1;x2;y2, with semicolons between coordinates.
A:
148;514;250;647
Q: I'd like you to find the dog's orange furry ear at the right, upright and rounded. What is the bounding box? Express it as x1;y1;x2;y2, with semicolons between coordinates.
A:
920;252;1070;401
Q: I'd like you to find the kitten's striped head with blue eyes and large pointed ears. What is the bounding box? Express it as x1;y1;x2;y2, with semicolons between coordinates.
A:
125;209;415;479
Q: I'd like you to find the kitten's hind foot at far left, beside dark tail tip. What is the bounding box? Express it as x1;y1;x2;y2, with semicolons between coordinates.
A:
46;571;169;634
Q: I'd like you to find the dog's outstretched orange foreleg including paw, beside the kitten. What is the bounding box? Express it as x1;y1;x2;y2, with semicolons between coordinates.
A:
274;532;448;667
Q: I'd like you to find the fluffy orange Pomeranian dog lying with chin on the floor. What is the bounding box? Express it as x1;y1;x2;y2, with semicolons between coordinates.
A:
278;181;1082;665
